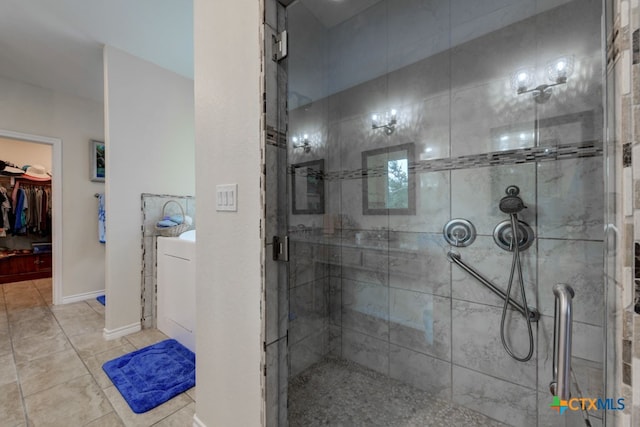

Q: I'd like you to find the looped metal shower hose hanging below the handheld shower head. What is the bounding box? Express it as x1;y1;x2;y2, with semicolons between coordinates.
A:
500;213;533;362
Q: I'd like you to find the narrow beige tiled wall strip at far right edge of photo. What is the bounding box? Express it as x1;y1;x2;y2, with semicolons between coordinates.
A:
607;0;640;425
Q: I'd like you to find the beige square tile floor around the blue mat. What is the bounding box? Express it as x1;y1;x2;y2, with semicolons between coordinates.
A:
0;279;195;427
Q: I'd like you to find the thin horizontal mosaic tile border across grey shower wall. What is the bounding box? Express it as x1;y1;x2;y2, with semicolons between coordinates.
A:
325;141;603;180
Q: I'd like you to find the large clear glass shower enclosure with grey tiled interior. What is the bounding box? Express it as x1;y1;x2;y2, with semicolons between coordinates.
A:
265;0;611;426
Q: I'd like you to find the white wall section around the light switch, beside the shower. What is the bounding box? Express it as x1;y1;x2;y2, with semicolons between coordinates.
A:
194;0;263;427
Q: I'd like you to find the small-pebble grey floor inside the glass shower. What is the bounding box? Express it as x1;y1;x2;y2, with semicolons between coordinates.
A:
289;358;506;427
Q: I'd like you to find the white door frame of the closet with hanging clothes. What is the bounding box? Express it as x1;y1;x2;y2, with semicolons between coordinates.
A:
0;129;62;305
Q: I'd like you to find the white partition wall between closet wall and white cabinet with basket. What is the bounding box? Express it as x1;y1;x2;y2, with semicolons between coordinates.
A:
104;46;195;338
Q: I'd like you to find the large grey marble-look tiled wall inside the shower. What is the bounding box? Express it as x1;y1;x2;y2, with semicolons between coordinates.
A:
289;0;605;426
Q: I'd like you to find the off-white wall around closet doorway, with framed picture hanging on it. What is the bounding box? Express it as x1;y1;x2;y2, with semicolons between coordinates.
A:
0;77;104;298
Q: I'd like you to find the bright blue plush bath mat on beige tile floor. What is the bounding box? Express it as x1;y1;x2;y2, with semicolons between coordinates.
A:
102;339;196;414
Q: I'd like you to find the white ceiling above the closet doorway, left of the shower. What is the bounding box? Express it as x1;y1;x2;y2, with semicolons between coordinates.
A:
0;0;193;102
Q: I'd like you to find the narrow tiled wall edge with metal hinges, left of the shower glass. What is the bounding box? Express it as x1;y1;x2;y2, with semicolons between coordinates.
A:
263;0;289;426
